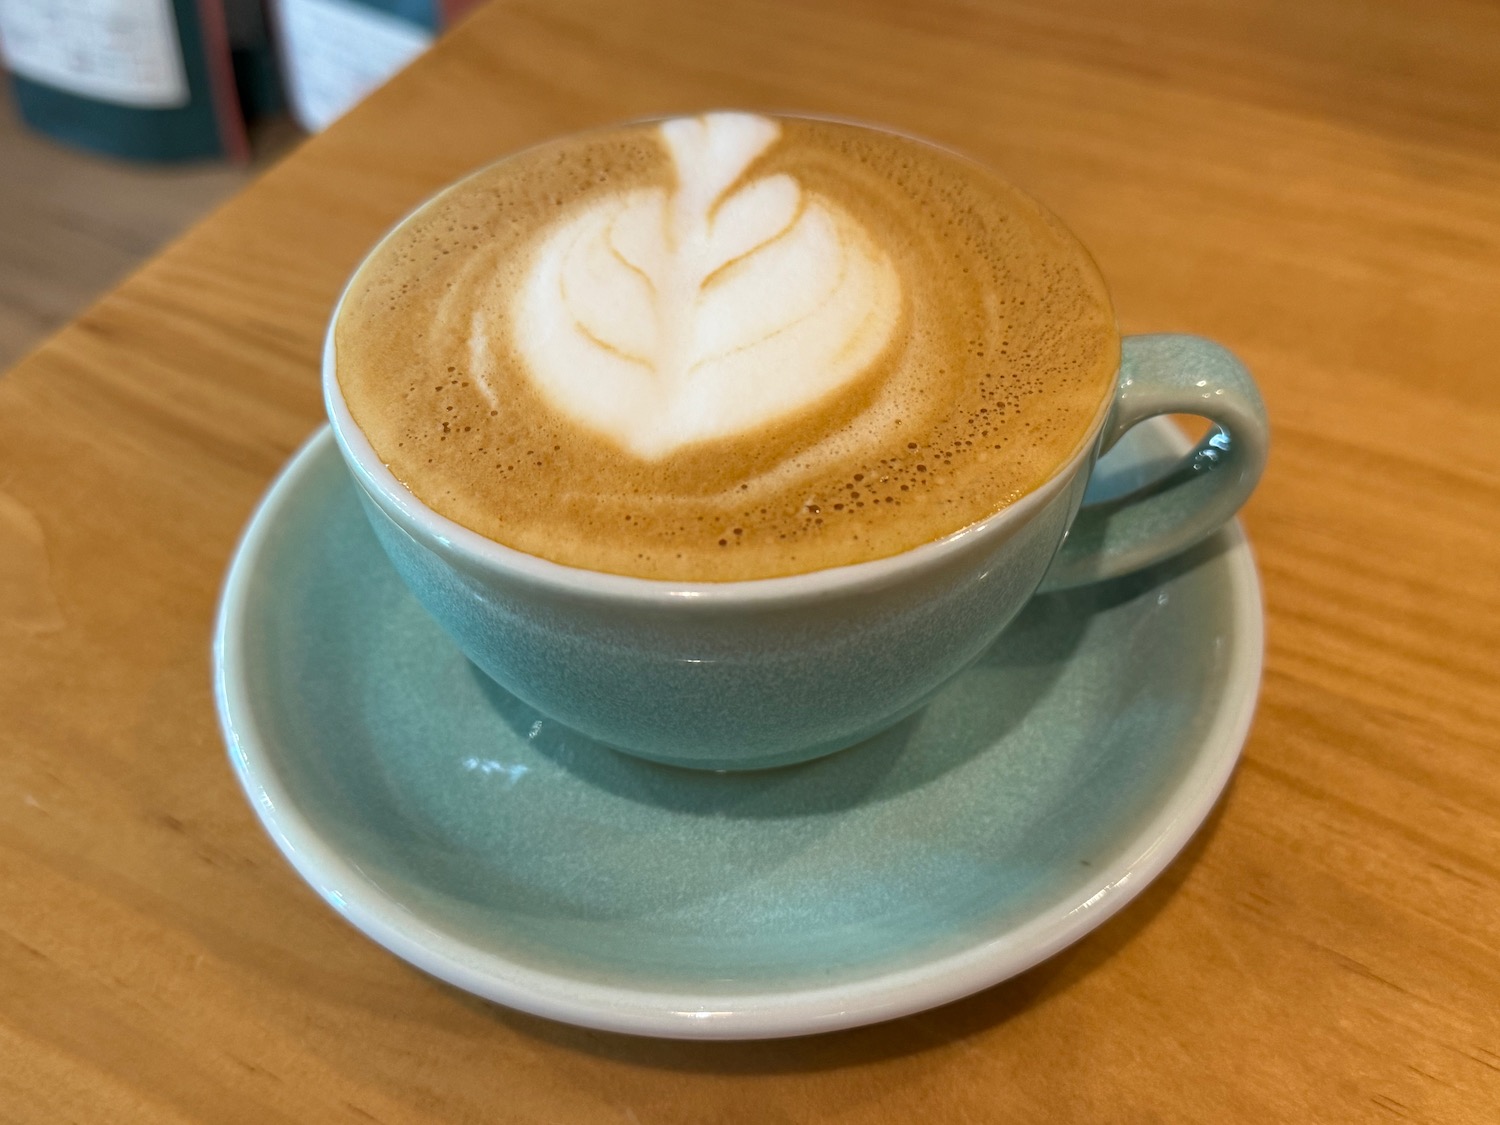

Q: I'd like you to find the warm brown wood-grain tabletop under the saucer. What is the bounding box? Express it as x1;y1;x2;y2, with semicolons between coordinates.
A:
0;0;1500;1125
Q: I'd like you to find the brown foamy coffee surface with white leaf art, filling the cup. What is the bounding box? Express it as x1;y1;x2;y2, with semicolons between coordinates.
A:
335;114;1119;581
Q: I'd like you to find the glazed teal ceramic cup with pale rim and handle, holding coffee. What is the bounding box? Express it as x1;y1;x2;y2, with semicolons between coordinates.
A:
323;312;1268;770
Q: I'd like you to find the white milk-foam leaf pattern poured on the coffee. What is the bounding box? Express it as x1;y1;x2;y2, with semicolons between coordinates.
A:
507;114;900;459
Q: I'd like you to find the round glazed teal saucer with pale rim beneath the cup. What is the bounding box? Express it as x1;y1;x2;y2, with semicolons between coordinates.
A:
215;420;1262;1038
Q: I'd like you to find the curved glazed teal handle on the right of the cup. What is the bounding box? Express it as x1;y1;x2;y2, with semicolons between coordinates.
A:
1041;333;1271;590
